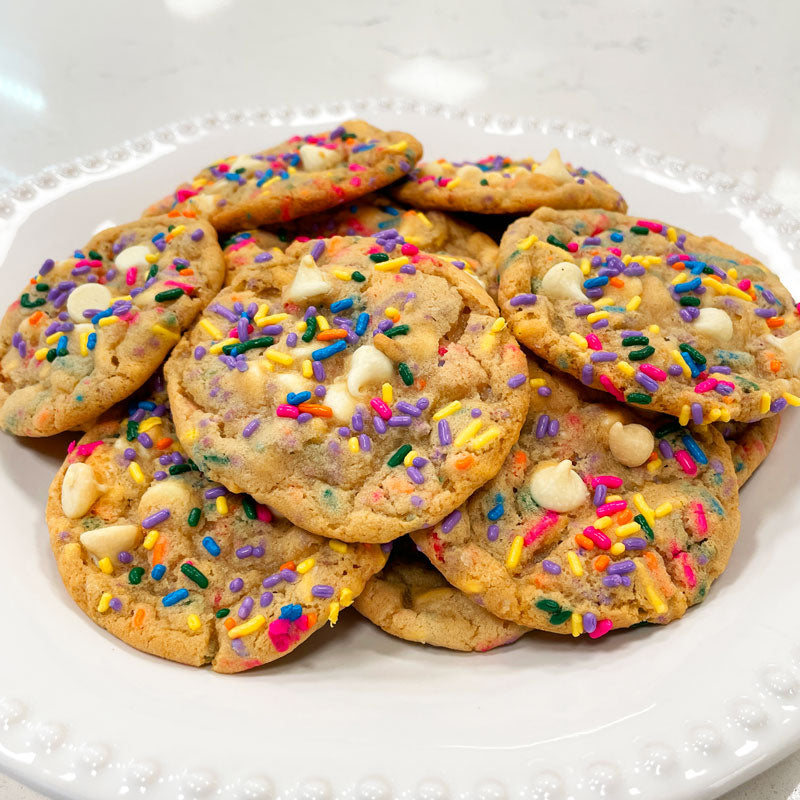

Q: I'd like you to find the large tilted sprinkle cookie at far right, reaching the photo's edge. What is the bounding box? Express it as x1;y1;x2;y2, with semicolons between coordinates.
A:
498;209;800;424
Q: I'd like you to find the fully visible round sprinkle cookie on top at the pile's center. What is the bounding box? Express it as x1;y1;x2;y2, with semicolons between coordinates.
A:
165;230;529;542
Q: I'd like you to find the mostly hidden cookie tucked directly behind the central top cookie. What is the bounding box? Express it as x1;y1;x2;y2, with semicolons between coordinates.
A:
219;195;498;301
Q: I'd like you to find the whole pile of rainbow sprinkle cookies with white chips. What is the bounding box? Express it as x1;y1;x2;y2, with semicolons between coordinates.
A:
0;120;800;672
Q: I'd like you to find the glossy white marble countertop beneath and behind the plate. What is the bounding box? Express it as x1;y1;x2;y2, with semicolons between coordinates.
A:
0;0;800;800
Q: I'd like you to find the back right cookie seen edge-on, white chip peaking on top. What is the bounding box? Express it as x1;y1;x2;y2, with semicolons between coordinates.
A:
391;150;628;214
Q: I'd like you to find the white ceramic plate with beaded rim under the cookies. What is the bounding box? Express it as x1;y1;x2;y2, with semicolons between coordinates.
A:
0;101;800;800
